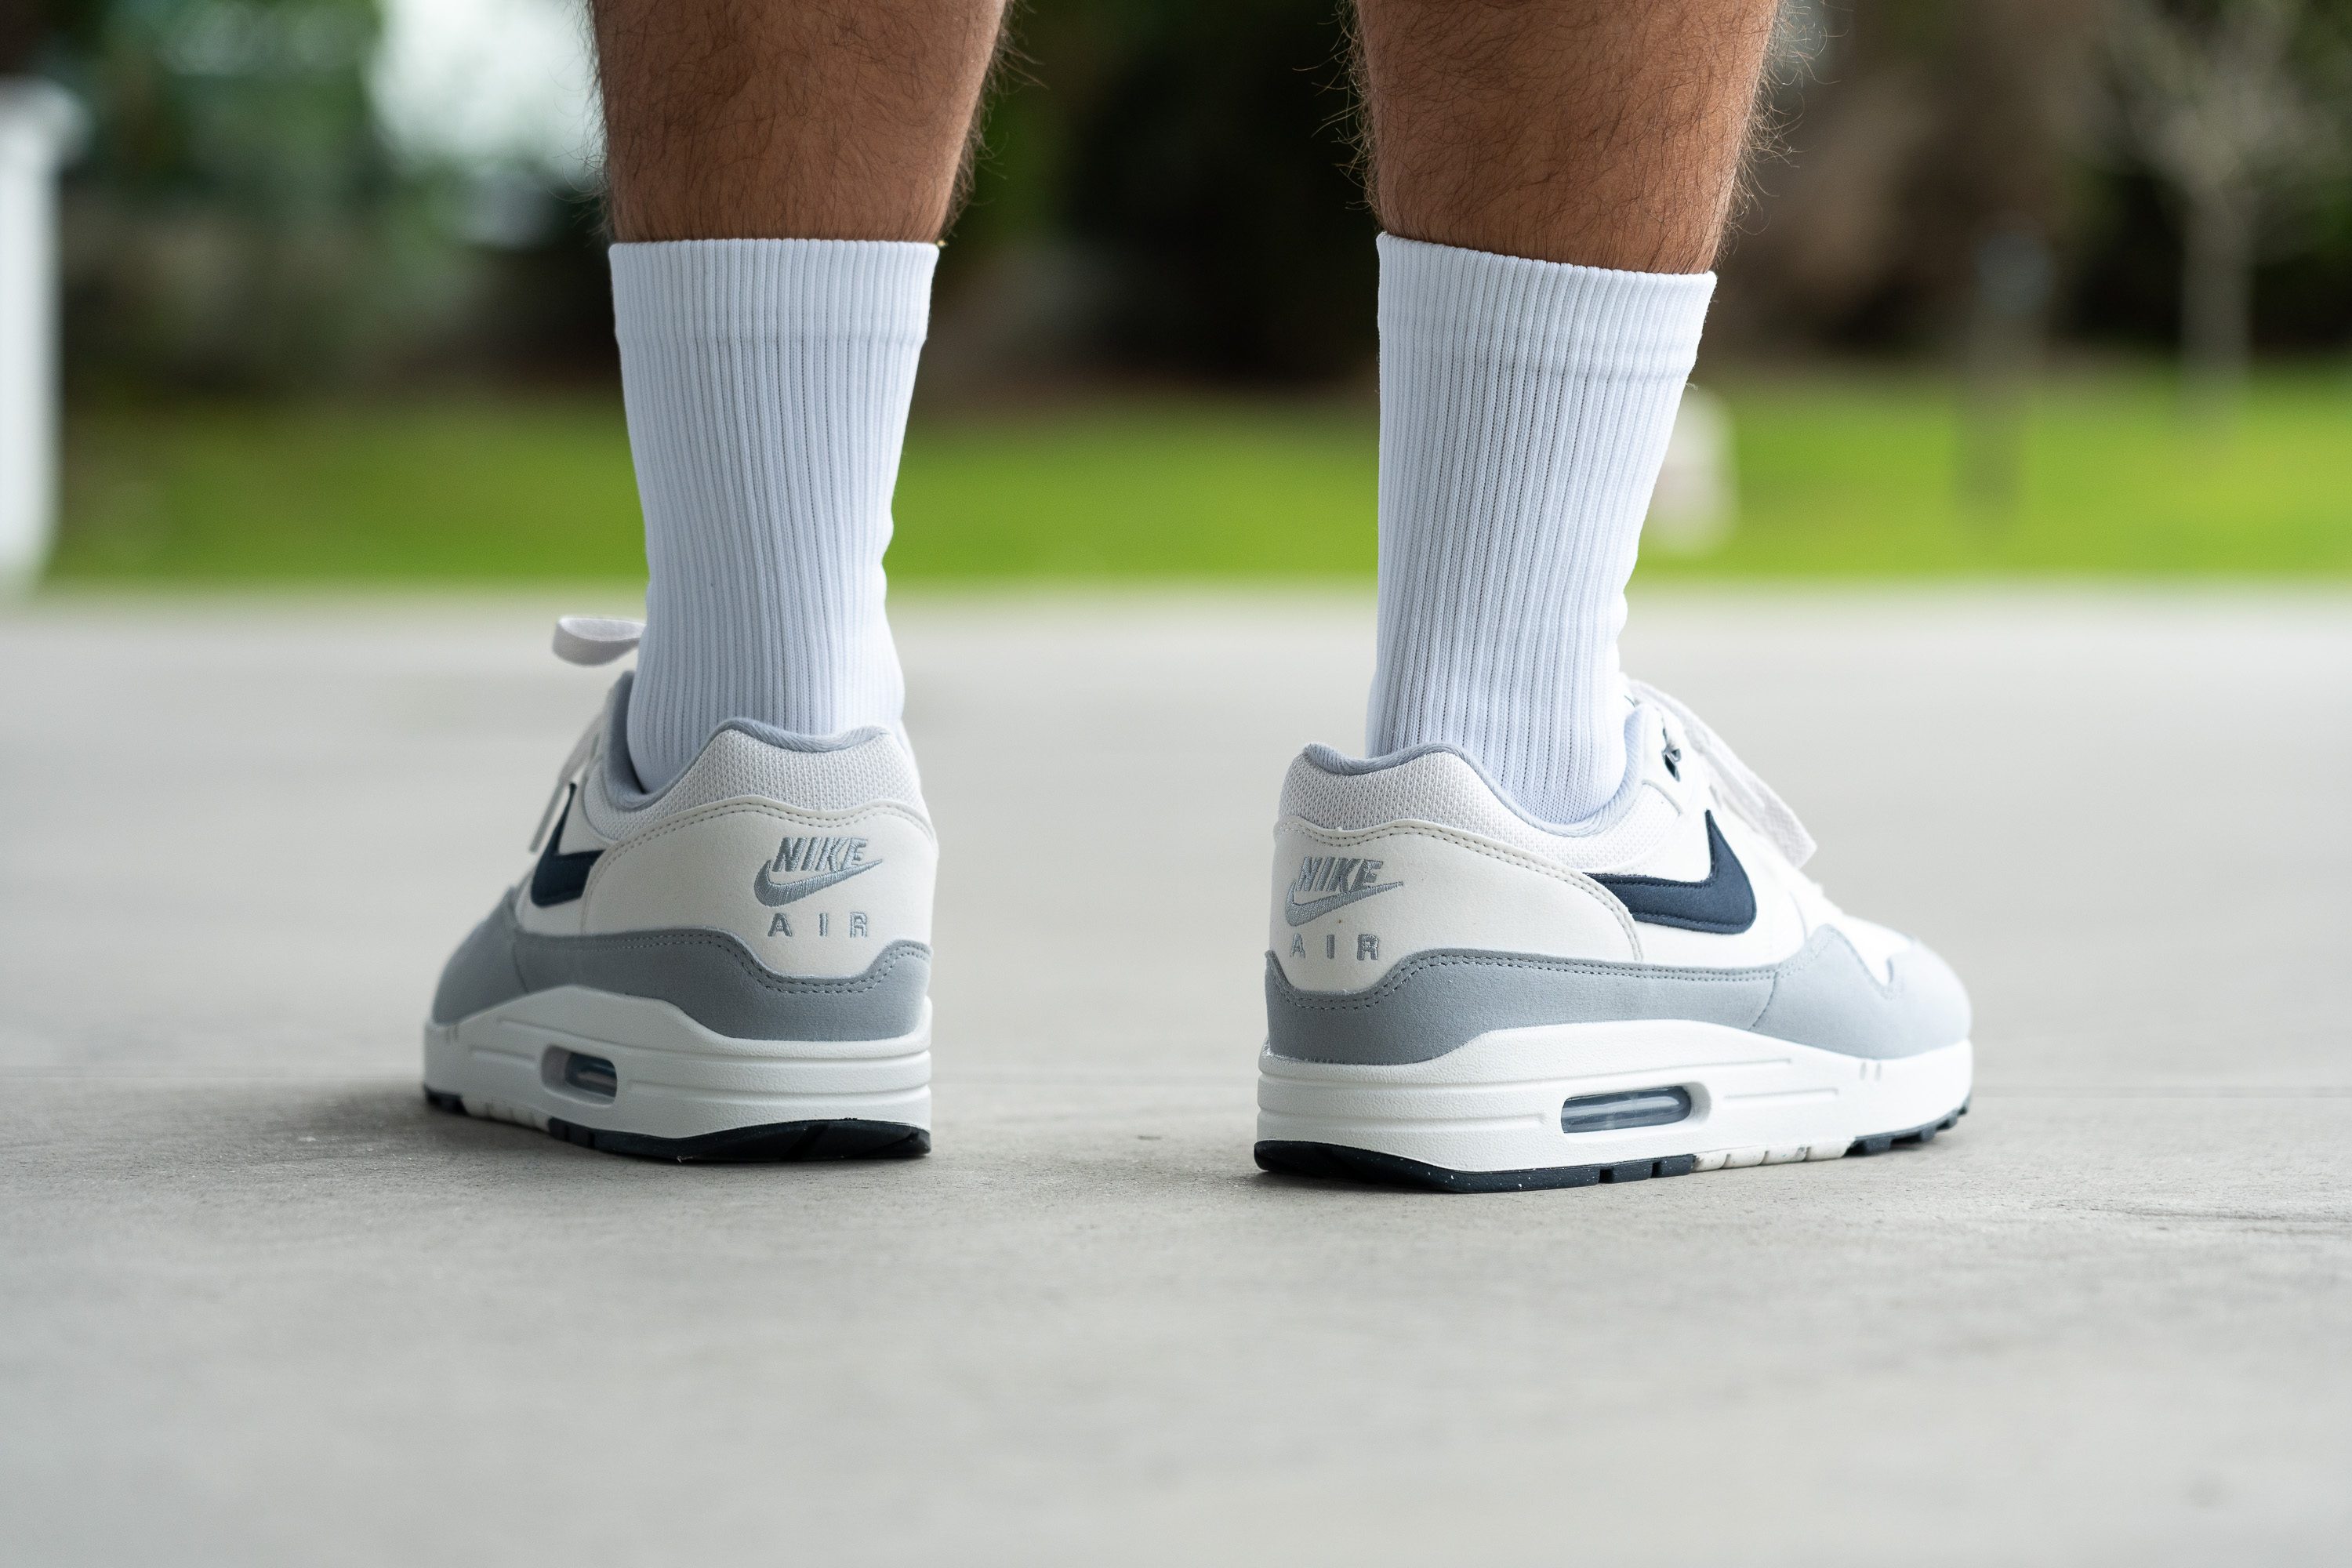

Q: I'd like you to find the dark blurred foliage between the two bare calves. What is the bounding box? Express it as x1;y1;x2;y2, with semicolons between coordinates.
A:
948;0;1376;381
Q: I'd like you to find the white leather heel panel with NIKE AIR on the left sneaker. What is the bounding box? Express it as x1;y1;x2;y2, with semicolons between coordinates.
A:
581;799;938;978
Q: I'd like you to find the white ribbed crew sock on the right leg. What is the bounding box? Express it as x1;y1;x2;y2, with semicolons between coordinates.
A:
1367;235;1715;822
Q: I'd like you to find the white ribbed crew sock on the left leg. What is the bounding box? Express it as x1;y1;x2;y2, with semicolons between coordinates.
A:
612;240;938;789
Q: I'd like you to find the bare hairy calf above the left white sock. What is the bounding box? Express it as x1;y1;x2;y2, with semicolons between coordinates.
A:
595;0;1004;240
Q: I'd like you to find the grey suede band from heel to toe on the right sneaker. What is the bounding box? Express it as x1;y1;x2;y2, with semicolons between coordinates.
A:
1265;928;1969;1067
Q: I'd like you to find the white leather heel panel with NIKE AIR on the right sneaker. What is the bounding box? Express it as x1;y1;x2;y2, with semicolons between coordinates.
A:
1268;818;1642;992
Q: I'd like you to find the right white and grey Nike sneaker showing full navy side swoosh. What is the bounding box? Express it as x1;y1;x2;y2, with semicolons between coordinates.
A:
1256;684;1971;1192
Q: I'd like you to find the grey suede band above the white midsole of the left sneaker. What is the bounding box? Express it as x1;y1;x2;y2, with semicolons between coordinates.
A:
433;900;931;1039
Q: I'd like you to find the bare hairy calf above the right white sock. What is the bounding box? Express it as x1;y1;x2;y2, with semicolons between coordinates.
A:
1357;0;1776;273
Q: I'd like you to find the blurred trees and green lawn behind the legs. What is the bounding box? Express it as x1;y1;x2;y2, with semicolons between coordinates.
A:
13;0;2352;583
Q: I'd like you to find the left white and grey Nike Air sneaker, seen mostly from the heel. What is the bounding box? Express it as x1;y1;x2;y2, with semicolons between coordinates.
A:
426;620;938;1159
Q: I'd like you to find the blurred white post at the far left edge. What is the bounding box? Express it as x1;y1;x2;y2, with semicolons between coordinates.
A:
0;78;82;595
